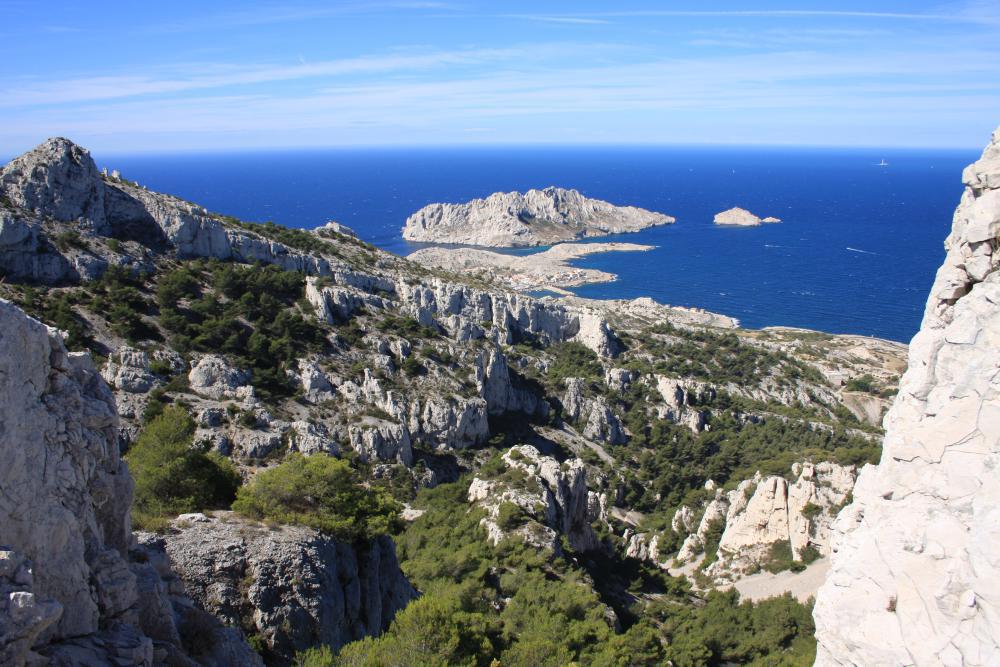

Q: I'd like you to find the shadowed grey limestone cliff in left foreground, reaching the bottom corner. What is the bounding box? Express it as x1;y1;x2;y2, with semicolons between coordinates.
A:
0;300;260;665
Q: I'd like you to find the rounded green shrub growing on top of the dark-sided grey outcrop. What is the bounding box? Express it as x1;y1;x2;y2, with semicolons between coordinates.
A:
233;454;400;540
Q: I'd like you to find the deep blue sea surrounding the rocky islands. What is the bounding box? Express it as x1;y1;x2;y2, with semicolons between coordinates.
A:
96;147;977;342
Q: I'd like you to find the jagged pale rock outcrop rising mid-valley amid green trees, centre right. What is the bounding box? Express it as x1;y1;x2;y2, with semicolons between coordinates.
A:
468;445;598;551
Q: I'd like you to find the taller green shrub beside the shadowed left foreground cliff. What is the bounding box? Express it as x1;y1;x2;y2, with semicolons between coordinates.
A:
125;406;240;529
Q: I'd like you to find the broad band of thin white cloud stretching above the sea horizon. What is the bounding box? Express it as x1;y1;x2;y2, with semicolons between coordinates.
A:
0;44;1000;151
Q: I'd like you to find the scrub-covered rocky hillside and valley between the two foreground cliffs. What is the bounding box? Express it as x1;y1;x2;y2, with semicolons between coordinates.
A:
0;139;905;665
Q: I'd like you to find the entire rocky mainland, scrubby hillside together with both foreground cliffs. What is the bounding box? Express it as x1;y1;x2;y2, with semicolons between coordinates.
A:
0;132;1000;666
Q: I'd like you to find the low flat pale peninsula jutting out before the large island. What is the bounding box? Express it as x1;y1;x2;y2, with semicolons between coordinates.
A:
407;243;655;293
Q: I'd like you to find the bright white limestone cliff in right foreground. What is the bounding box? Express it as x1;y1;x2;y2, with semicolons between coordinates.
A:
814;130;1000;666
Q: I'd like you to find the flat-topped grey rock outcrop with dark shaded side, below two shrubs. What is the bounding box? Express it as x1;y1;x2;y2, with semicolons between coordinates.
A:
163;513;416;663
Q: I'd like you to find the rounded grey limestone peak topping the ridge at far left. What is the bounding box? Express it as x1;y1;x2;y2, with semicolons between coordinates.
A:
0;137;111;234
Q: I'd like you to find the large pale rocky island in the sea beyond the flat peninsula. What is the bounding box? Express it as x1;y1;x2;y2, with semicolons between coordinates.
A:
403;187;674;247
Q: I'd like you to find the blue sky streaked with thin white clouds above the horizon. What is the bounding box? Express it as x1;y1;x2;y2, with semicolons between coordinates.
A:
0;0;1000;155
